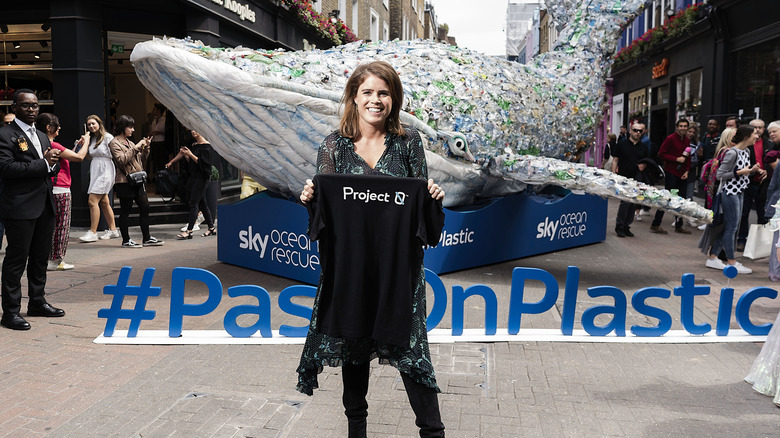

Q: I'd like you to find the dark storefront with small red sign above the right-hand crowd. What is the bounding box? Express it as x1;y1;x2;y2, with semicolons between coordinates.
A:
612;0;780;151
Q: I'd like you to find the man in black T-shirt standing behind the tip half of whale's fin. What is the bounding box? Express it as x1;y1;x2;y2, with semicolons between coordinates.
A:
612;123;648;237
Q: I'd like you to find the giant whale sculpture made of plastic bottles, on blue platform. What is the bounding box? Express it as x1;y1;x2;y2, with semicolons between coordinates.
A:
130;0;712;222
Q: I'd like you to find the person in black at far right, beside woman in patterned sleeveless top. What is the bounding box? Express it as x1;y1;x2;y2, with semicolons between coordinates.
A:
737;119;775;252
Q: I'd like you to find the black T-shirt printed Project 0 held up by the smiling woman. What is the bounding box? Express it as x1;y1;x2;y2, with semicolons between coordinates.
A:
307;174;444;346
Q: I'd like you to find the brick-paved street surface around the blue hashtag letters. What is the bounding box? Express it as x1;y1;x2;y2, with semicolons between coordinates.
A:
0;201;780;438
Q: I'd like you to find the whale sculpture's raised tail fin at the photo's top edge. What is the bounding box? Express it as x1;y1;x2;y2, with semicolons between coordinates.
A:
547;0;652;57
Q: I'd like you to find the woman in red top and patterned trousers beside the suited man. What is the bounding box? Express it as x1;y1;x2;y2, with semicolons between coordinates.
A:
35;113;87;271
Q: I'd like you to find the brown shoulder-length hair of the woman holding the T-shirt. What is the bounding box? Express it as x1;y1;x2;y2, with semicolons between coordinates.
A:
339;61;404;140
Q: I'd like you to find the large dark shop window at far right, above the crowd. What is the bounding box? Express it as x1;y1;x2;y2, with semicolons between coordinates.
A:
728;38;780;123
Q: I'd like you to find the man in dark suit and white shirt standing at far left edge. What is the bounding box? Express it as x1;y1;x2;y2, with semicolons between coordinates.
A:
0;89;65;330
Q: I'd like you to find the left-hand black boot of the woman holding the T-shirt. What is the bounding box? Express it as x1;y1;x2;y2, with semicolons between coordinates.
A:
341;362;371;438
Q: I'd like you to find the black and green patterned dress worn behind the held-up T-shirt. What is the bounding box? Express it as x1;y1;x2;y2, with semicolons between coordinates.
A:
296;126;439;395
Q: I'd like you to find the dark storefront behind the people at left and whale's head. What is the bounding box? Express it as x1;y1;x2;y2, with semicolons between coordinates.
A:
0;0;332;226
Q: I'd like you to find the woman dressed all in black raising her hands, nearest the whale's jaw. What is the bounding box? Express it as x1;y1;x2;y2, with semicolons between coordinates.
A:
165;129;217;240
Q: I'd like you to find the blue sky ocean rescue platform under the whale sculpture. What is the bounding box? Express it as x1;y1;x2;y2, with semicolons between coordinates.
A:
217;192;607;284
